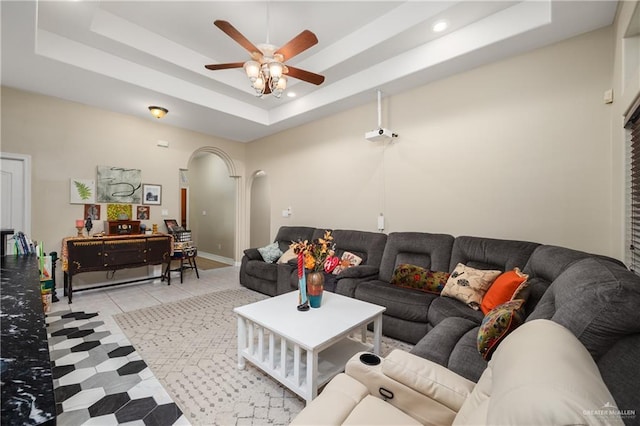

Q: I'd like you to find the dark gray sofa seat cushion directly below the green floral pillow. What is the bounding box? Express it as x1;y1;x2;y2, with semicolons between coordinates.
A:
358;280;438;324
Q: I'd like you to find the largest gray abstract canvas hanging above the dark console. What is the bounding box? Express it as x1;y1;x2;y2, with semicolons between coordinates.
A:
96;166;142;204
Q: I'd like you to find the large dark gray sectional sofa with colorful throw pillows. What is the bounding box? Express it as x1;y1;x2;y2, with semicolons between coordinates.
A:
240;227;640;424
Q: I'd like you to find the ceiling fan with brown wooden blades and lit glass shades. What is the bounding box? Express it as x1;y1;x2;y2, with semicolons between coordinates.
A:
205;20;324;98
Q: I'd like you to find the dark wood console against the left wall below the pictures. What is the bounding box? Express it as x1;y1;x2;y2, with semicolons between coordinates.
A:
62;234;173;303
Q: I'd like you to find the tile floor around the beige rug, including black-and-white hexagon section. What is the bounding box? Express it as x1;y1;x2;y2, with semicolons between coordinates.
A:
47;267;239;426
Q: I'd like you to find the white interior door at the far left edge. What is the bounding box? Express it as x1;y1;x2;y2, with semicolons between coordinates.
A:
0;152;31;253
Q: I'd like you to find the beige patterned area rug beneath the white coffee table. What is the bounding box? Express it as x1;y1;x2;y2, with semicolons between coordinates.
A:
114;288;411;425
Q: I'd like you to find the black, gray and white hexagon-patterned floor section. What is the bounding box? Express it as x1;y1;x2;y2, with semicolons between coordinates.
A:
47;310;189;425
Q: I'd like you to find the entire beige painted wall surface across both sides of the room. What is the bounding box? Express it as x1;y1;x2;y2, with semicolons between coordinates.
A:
1;13;640;261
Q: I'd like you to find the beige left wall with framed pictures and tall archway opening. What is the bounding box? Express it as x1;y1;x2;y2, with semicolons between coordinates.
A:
1;87;246;260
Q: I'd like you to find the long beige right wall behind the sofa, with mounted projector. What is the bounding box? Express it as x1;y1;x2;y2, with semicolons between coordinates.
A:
247;27;619;255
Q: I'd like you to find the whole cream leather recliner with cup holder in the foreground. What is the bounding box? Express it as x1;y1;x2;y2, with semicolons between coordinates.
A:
292;320;625;426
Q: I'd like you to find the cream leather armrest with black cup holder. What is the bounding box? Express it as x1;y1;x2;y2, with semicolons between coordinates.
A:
345;350;475;424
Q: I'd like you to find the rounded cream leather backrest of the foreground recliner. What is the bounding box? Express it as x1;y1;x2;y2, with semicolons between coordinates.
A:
453;320;622;425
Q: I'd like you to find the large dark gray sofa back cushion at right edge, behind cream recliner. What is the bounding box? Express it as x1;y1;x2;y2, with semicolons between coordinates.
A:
527;257;640;361
